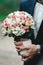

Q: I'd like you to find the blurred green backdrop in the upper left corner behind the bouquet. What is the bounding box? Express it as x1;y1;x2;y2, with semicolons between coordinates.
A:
0;0;20;21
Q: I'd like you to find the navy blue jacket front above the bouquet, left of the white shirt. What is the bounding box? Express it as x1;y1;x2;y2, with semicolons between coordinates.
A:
20;0;36;16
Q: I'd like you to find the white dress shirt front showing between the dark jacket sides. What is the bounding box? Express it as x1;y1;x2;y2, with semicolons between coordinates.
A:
34;2;43;38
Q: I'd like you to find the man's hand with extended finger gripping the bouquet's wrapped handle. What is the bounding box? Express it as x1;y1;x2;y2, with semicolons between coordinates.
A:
16;44;38;61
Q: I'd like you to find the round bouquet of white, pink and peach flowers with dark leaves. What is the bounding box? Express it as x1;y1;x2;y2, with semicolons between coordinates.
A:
2;11;34;54
